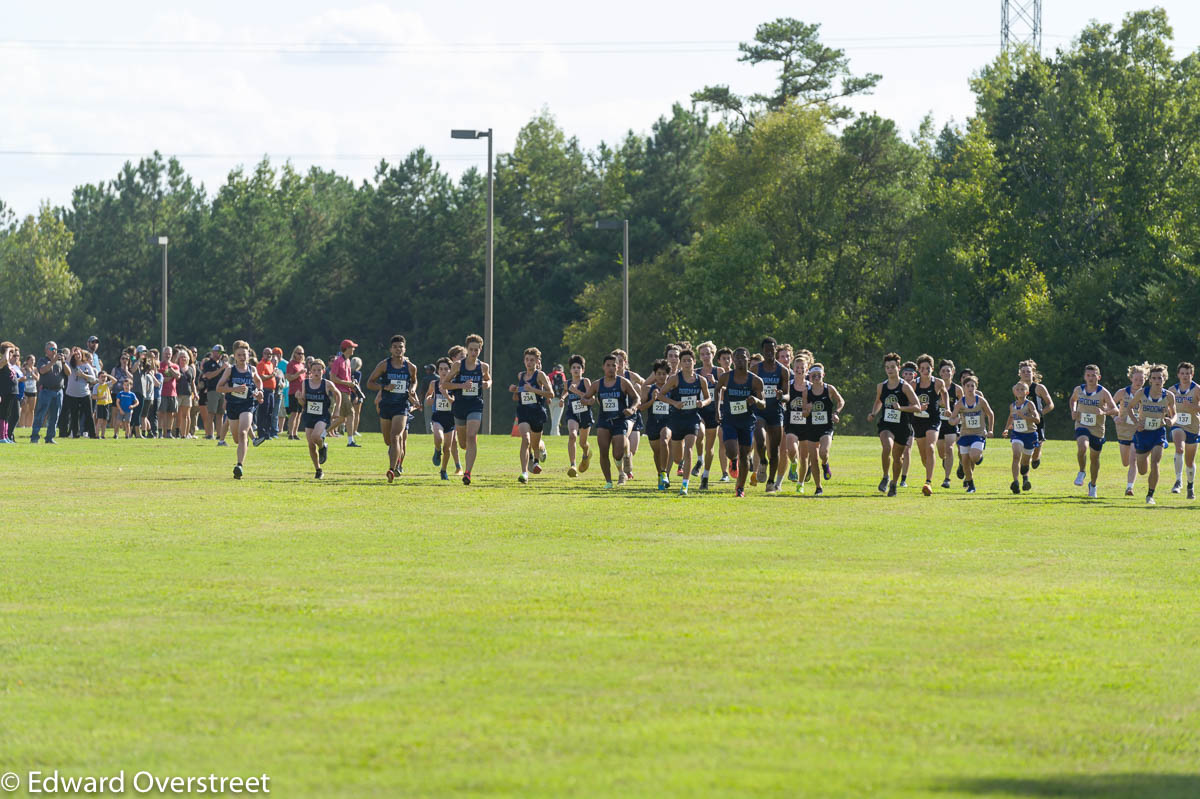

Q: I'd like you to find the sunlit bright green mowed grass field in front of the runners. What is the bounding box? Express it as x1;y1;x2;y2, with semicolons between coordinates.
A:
0;435;1200;798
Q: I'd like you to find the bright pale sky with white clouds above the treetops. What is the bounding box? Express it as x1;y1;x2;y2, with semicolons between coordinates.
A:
0;0;1200;216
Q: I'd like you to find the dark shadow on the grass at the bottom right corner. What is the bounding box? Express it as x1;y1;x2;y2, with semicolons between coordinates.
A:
936;773;1200;799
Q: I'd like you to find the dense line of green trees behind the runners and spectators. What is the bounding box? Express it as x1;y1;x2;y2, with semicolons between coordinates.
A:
0;10;1200;433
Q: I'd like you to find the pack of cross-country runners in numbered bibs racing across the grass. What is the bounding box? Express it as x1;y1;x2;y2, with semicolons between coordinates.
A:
208;335;1200;504
